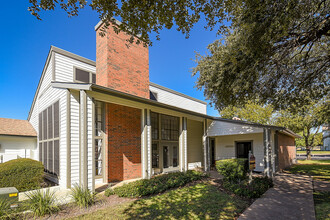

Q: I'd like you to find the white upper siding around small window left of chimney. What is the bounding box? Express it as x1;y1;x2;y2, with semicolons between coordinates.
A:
55;53;96;82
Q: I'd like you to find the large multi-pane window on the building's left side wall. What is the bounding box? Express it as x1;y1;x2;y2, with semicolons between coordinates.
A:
39;101;60;176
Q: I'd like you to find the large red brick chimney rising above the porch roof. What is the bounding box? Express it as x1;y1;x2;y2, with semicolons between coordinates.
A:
95;19;149;99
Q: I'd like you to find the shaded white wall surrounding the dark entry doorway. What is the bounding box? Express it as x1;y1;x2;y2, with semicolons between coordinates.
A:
215;133;264;171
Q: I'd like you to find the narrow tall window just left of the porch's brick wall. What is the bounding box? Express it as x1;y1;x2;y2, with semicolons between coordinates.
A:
94;101;105;176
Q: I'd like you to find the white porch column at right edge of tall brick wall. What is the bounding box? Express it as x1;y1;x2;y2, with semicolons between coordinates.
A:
141;109;152;179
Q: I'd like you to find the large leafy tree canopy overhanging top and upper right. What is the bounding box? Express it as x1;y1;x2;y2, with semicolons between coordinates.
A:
29;0;330;110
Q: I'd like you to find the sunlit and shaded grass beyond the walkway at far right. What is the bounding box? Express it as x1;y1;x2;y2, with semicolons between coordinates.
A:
287;160;330;181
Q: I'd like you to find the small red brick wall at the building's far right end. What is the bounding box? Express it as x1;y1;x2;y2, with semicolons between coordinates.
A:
278;133;296;170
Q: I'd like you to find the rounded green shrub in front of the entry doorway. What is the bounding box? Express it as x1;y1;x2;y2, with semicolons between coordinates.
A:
216;158;248;183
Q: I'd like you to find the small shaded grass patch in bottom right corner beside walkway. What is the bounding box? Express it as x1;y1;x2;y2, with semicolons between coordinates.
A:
314;192;330;220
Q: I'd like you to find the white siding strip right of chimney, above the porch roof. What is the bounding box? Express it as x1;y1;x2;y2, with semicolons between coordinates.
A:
149;85;206;114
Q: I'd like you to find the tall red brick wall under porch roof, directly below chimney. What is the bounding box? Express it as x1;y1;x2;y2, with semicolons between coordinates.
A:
106;104;142;182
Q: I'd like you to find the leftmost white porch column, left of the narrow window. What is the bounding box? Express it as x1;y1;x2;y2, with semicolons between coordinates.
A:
79;90;88;187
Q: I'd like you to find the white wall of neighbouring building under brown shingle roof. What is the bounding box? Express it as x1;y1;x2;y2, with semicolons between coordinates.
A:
0;136;38;163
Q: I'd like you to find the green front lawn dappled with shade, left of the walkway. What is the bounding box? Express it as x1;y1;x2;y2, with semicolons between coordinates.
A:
71;183;249;220
